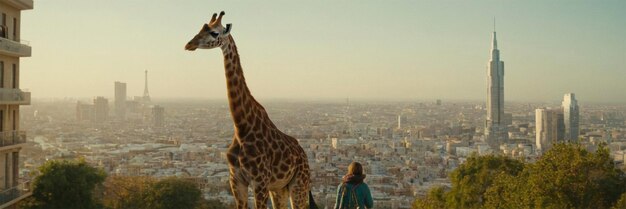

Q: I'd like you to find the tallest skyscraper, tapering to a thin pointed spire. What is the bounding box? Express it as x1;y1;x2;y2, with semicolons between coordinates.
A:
485;30;509;148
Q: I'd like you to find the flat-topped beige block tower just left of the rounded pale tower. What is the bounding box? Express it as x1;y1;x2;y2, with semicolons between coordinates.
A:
535;108;565;152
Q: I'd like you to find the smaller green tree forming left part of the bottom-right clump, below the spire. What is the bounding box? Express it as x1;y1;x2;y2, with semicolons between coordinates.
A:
446;154;524;208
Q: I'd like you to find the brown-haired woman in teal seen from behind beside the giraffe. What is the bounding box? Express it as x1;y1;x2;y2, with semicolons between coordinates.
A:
335;162;374;209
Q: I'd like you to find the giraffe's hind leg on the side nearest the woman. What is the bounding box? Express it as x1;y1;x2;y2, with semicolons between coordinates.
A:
289;169;311;209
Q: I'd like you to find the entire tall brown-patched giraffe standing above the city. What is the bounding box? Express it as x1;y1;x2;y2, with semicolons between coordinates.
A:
185;11;317;209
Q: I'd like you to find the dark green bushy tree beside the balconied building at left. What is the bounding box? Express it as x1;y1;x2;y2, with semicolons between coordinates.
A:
21;159;106;209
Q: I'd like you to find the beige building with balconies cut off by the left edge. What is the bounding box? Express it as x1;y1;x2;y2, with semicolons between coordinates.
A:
0;0;33;209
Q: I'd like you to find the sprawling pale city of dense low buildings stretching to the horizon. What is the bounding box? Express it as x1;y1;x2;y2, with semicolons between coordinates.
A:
15;98;626;208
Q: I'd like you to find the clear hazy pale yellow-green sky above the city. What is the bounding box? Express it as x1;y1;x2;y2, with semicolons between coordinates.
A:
21;0;626;103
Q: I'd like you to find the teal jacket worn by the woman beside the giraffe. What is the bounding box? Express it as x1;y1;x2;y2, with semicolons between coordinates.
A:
335;183;374;209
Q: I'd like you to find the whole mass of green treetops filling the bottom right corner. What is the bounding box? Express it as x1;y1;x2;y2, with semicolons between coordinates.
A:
413;144;626;208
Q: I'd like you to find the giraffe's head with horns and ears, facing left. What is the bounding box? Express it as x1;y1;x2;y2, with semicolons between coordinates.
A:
185;11;231;51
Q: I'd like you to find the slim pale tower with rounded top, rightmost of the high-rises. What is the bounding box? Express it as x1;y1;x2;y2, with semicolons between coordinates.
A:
562;93;580;142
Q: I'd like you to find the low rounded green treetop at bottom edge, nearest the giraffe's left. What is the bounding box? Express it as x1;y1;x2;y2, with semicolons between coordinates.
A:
146;178;202;209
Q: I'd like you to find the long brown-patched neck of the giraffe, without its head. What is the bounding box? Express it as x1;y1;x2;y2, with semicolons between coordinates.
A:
221;35;274;137
